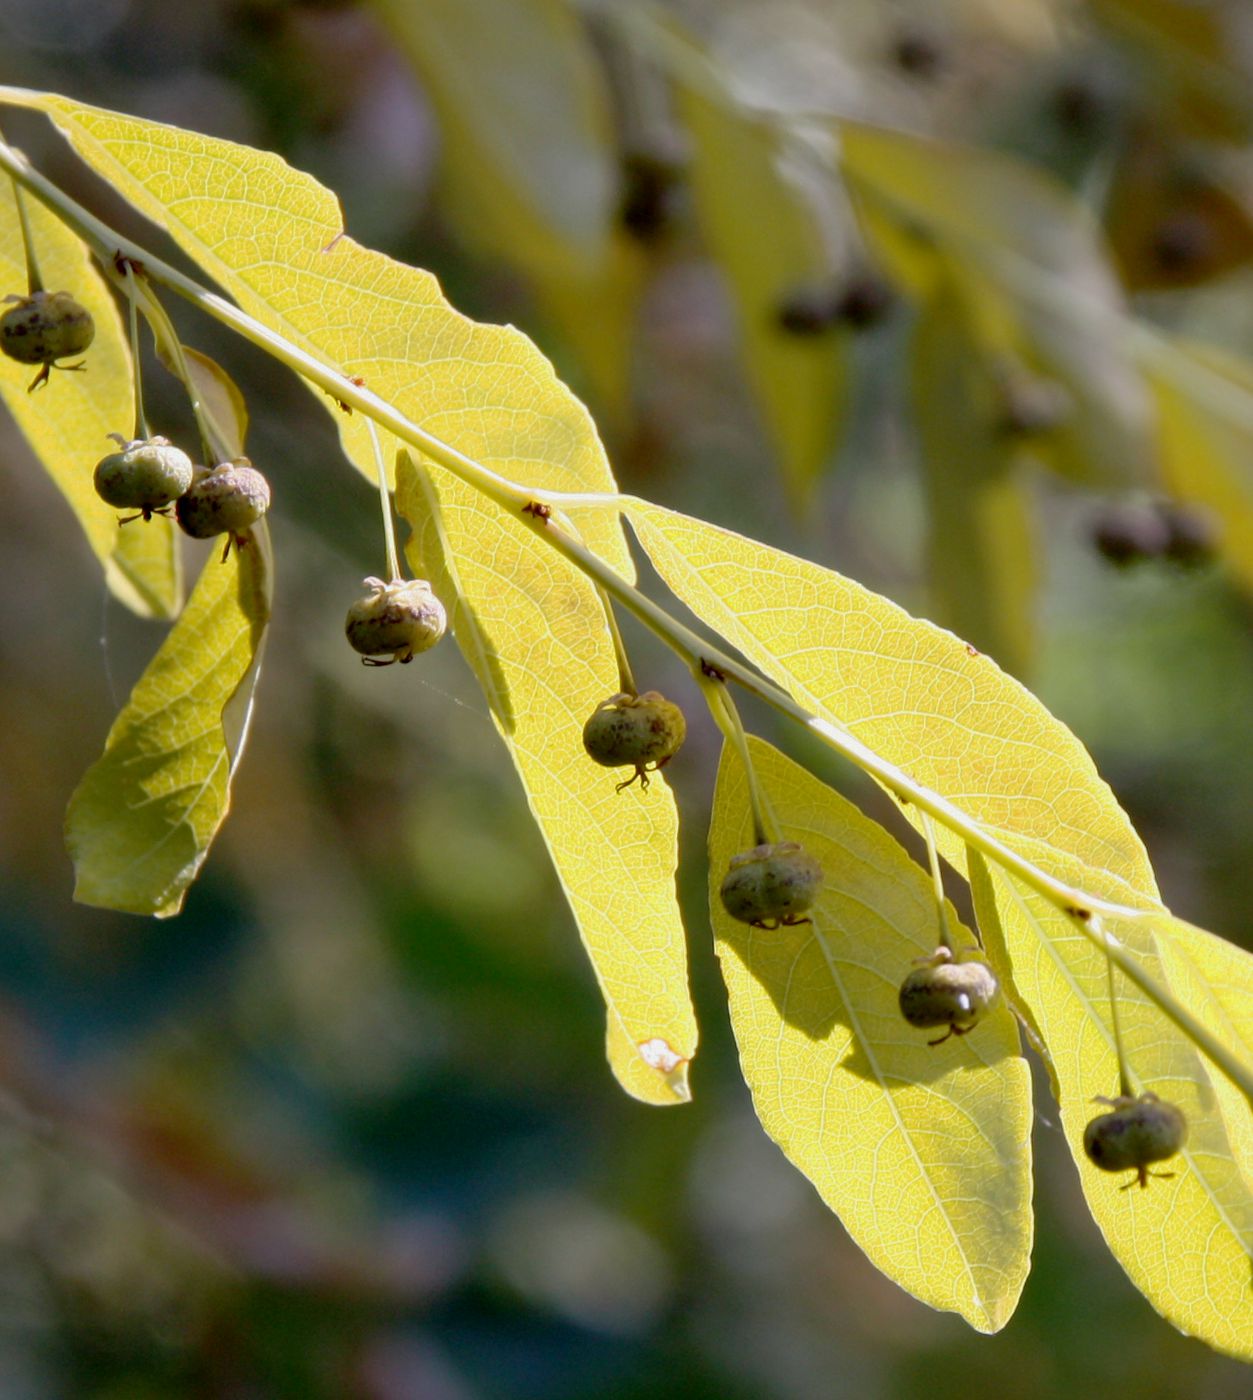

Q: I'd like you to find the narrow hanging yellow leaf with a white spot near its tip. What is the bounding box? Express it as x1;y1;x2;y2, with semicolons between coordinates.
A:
396;458;696;1103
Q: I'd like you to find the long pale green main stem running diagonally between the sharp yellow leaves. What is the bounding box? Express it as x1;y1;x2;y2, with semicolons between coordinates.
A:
0;133;1253;1102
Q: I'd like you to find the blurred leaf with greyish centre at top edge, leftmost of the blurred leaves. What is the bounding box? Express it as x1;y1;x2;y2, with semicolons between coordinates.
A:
372;0;643;419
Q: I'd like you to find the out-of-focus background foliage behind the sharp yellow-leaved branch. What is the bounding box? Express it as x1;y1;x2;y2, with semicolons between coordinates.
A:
0;0;1253;1400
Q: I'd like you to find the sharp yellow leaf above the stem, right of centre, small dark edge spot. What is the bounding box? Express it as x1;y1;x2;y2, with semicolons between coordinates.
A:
623;500;1155;897
